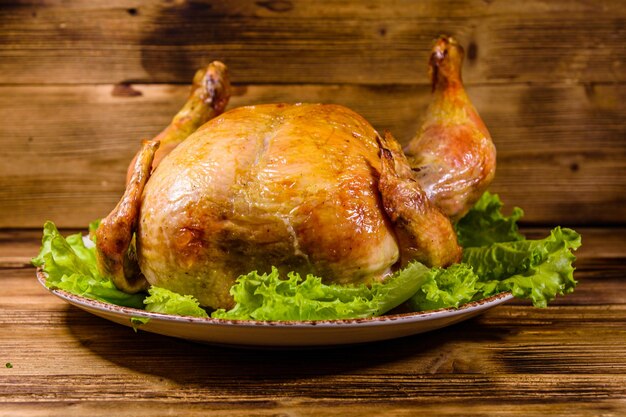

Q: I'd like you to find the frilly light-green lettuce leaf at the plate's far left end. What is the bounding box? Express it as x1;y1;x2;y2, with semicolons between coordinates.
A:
32;222;145;308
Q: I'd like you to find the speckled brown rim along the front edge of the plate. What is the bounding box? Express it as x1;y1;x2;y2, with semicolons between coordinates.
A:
36;267;514;328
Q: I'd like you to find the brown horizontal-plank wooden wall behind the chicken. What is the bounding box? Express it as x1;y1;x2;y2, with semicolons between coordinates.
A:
0;0;626;228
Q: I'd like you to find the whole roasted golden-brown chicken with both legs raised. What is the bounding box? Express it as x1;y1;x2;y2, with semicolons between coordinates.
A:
96;36;495;308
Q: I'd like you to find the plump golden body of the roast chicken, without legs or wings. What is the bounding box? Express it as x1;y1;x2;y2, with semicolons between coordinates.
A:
138;104;399;307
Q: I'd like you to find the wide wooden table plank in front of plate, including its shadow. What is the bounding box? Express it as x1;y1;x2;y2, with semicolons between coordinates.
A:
0;313;626;409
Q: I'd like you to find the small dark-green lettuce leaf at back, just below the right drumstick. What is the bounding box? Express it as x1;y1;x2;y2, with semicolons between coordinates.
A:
455;192;524;248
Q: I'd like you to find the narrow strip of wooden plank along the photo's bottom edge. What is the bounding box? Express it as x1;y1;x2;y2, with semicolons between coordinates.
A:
5;399;626;417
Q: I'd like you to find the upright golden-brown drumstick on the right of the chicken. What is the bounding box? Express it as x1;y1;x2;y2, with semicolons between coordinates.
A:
405;36;496;220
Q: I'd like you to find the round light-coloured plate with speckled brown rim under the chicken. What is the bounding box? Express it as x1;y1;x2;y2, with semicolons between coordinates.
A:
37;270;513;346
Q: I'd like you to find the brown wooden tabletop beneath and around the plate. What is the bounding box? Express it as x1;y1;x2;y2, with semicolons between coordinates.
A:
0;228;626;417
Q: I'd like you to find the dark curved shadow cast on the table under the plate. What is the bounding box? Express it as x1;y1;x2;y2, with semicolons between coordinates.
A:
66;306;510;389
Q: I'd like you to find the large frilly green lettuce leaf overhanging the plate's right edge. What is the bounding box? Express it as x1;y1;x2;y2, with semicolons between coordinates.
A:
409;227;581;311
